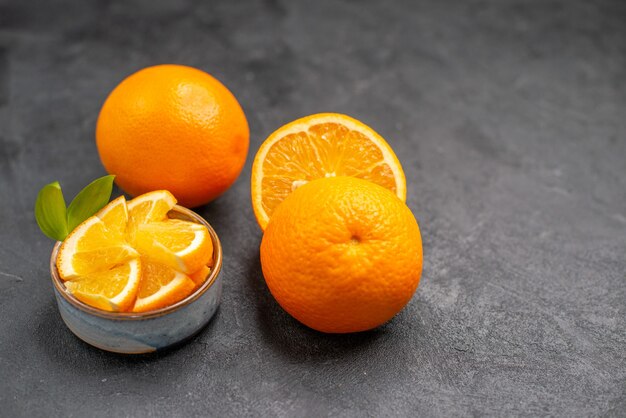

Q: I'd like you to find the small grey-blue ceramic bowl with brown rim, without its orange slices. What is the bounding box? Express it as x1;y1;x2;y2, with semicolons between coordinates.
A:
50;206;222;354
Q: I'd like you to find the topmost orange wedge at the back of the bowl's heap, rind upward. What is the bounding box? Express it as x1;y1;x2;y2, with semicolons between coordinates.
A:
126;190;176;242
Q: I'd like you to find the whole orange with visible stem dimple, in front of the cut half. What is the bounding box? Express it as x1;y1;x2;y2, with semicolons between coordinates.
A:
261;177;422;333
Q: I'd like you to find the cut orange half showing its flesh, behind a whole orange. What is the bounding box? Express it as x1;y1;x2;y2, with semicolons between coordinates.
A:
251;113;406;229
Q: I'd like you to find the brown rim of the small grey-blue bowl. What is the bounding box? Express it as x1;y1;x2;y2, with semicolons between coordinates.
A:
50;205;222;321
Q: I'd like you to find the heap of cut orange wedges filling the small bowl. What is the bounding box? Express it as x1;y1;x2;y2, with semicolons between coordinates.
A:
56;190;213;312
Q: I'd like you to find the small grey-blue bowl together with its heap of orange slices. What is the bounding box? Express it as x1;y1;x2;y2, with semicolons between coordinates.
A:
50;190;222;354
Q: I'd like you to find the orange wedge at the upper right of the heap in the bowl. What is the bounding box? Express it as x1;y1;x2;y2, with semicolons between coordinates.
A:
134;219;213;273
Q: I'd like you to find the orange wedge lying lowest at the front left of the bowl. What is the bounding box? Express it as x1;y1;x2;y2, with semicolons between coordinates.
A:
65;259;142;312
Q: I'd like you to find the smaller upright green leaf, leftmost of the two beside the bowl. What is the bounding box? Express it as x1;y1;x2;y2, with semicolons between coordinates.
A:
35;181;69;241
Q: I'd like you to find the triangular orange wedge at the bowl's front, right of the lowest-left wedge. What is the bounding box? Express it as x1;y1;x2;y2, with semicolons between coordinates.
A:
132;257;196;312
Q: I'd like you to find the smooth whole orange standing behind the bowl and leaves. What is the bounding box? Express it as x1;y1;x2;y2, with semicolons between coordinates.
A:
96;65;250;207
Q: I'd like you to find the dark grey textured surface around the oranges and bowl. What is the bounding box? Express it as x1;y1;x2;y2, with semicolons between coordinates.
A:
0;0;626;417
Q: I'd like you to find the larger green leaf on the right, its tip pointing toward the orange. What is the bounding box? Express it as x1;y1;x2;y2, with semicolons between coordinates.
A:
67;175;115;231
